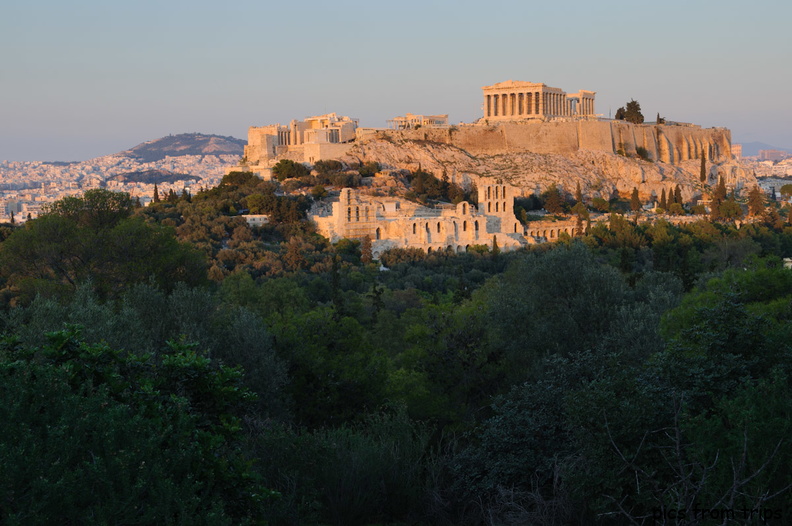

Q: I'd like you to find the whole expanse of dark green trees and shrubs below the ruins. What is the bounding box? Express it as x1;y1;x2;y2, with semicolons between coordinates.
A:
0;185;792;525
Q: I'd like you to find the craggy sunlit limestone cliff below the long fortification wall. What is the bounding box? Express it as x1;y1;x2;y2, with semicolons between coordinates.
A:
340;138;757;200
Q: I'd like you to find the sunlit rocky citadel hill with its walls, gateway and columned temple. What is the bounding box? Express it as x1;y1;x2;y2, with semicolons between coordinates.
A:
240;81;756;206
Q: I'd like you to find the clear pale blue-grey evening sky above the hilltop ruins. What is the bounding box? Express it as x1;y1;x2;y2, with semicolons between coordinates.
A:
0;0;792;161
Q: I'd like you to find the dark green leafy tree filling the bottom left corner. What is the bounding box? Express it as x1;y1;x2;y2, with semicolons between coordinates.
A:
0;330;270;525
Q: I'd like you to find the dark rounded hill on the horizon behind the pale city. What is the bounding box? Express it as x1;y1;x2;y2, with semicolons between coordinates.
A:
117;133;247;163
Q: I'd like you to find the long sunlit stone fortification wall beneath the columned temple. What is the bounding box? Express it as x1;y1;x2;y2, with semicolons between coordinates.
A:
377;121;731;164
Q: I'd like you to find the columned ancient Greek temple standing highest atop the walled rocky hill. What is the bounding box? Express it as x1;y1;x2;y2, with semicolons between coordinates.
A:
481;80;596;121
